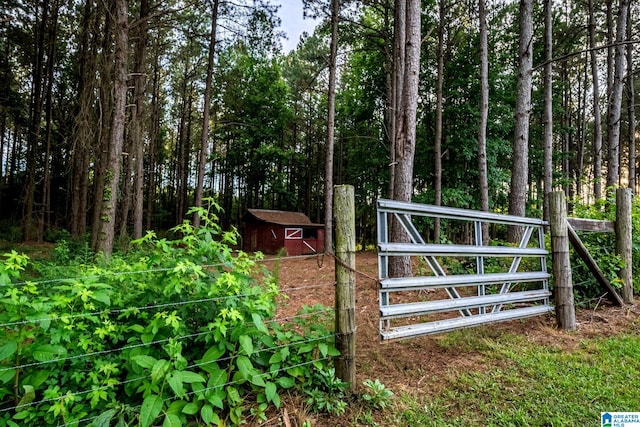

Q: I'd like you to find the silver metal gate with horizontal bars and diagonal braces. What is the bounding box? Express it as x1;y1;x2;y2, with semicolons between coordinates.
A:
377;200;553;340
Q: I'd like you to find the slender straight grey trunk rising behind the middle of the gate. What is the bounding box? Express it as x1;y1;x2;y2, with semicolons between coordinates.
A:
478;0;489;237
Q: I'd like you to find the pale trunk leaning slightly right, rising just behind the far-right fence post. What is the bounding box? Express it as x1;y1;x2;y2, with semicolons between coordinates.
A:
607;0;629;189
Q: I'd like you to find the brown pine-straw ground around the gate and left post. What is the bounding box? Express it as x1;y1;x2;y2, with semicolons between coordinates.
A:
267;252;640;426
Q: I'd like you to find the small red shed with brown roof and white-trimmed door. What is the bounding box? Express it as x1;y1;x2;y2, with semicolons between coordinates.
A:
242;209;324;255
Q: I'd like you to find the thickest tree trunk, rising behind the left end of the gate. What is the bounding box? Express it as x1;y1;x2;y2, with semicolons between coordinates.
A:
389;0;421;277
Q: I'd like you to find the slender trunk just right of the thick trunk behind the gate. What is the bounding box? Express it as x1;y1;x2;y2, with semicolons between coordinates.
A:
433;0;447;242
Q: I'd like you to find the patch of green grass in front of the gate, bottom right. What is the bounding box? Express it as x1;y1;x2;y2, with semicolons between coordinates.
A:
388;330;640;426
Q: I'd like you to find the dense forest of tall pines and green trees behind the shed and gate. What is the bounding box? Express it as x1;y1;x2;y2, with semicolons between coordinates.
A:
0;0;640;252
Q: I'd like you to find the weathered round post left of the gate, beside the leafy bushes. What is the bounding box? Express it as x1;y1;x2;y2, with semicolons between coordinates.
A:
333;185;356;390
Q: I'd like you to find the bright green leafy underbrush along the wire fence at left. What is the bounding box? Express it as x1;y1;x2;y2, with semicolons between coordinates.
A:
0;209;344;427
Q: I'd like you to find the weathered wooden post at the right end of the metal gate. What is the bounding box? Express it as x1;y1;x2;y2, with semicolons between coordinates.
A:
549;191;576;331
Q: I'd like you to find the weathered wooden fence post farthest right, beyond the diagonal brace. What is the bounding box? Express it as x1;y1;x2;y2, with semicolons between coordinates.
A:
616;188;633;304
